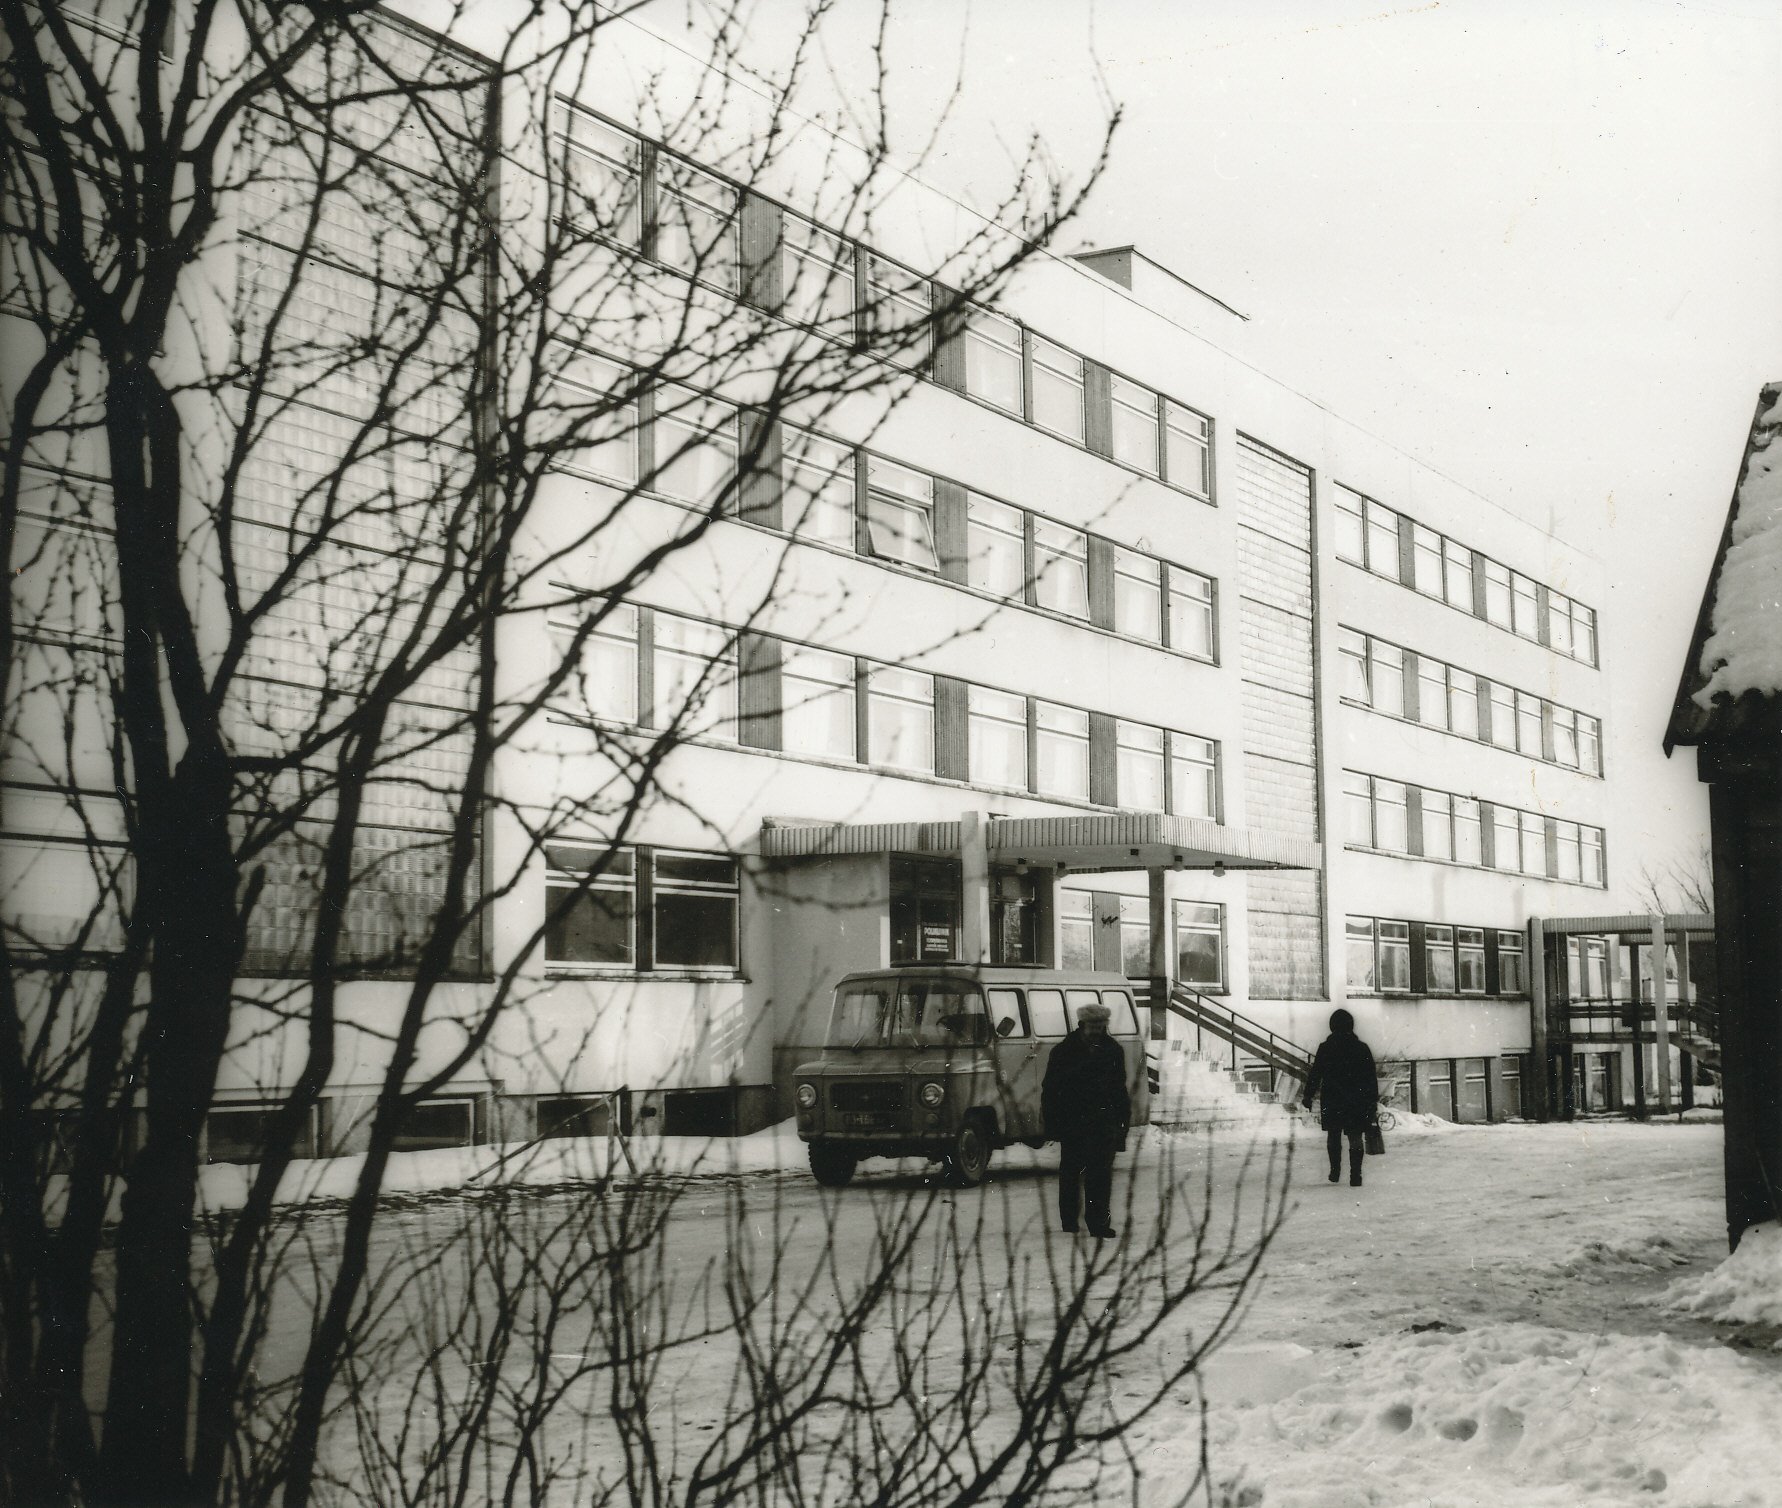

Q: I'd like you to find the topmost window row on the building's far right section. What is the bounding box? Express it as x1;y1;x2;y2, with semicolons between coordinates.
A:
1335;487;1597;665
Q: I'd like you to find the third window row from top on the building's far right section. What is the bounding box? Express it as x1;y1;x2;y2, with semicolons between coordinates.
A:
1342;770;1607;889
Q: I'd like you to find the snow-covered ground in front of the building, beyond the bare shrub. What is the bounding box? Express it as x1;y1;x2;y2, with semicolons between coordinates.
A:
205;1114;1782;1508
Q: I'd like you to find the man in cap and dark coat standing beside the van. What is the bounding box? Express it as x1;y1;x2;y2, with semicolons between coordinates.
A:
1039;1005;1132;1237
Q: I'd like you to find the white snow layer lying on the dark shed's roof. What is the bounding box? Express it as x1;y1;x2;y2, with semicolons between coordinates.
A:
1695;383;1782;708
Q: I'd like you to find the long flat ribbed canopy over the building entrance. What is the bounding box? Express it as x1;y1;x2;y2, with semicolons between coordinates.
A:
761;811;1322;873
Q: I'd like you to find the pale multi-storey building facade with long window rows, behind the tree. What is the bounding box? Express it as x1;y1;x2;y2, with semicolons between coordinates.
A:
7;8;1623;1155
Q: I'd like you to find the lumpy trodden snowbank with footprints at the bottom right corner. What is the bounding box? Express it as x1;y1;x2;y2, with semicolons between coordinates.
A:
1140;1324;1782;1508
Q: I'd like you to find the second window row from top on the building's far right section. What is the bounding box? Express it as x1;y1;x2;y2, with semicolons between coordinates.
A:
1337;627;1602;775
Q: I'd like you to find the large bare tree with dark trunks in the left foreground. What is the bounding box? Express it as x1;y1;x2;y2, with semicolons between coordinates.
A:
0;0;1119;1504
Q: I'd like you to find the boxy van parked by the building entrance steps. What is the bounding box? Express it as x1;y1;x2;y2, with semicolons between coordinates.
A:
793;964;1149;1187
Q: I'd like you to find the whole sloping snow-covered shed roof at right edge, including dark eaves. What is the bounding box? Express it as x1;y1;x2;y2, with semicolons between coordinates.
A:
1664;383;1782;750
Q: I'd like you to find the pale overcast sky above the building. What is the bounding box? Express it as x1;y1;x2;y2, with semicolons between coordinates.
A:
652;0;1782;891
